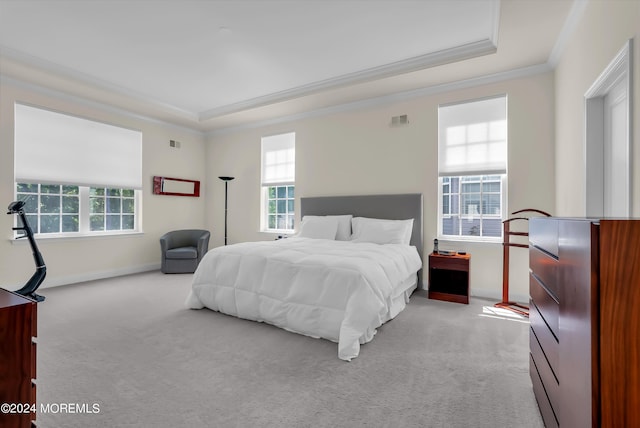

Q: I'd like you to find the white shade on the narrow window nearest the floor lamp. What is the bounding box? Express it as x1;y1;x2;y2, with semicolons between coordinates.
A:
262;132;296;186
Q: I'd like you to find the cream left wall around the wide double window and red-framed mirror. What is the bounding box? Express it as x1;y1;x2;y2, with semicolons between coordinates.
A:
0;81;207;289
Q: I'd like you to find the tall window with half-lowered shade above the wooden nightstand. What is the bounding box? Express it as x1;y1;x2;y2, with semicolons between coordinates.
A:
438;96;507;240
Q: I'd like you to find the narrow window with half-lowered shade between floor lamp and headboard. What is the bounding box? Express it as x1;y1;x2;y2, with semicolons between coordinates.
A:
261;132;296;232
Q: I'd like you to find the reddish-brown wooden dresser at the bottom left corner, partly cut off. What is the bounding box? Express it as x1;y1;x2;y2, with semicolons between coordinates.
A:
0;289;38;428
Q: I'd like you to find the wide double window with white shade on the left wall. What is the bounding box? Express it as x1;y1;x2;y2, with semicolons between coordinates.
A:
15;104;142;236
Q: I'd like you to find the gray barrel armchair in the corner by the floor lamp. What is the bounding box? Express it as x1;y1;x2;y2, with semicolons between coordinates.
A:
160;229;211;273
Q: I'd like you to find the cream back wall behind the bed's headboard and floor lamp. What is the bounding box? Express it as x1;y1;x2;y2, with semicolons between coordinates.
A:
206;73;555;301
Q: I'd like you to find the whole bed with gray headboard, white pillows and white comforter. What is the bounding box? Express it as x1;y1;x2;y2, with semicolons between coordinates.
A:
186;194;422;361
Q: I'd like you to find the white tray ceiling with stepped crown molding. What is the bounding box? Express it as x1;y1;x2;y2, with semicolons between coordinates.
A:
0;0;572;131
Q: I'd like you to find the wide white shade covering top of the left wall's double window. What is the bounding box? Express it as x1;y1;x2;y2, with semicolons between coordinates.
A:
15;104;142;190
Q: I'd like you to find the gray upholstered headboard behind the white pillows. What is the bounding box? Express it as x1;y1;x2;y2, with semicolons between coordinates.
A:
300;193;424;260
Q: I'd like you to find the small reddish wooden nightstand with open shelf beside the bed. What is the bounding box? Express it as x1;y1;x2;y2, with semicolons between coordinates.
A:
429;253;471;304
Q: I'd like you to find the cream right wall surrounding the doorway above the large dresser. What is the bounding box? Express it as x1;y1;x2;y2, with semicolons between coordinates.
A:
555;0;640;217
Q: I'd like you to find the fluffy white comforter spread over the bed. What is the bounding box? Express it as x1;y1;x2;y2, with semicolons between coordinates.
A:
186;238;422;361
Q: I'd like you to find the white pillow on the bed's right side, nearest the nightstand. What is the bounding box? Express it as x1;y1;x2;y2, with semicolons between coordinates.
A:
351;217;413;245
